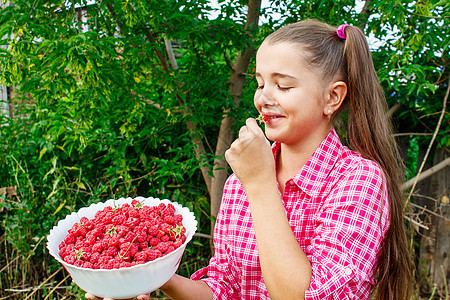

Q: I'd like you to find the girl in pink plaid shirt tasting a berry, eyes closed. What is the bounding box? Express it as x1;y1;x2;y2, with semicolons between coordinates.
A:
88;20;411;300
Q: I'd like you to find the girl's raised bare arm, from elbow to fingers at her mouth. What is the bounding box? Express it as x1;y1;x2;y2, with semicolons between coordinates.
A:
225;119;311;299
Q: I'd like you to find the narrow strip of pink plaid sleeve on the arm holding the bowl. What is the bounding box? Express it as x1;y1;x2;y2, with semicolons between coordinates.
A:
191;175;237;300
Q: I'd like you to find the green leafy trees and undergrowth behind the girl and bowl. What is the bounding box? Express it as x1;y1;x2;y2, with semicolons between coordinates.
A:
0;0;450;299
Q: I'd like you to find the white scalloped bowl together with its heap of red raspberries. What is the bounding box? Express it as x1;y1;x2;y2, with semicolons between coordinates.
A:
47;197;197;299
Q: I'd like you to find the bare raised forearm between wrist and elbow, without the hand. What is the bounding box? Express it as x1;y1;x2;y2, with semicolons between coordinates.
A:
246;182;311;300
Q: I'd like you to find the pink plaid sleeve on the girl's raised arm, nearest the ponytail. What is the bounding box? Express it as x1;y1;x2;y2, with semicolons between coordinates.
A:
305;162;388;300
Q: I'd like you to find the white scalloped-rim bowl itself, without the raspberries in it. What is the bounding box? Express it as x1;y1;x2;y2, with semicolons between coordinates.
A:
47;197;197;299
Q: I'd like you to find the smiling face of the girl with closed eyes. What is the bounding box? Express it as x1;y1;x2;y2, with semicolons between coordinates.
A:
254;42;330;146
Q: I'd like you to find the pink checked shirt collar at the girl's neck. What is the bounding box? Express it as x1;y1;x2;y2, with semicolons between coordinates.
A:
272;128;344;197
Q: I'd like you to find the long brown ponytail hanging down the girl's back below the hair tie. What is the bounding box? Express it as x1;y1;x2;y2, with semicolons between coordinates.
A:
344;26;411;300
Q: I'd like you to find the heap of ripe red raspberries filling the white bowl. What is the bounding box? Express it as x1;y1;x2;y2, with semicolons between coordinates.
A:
59;199;186;269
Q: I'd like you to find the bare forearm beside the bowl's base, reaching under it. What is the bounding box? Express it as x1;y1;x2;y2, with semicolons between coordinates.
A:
161;275;212;300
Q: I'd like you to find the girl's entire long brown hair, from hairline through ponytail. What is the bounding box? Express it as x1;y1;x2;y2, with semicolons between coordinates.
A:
266;20;411;300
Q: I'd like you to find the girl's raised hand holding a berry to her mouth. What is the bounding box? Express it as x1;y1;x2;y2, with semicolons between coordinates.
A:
225;118;275;187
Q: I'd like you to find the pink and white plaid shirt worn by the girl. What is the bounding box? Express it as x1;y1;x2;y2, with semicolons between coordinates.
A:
191;129;389;300
